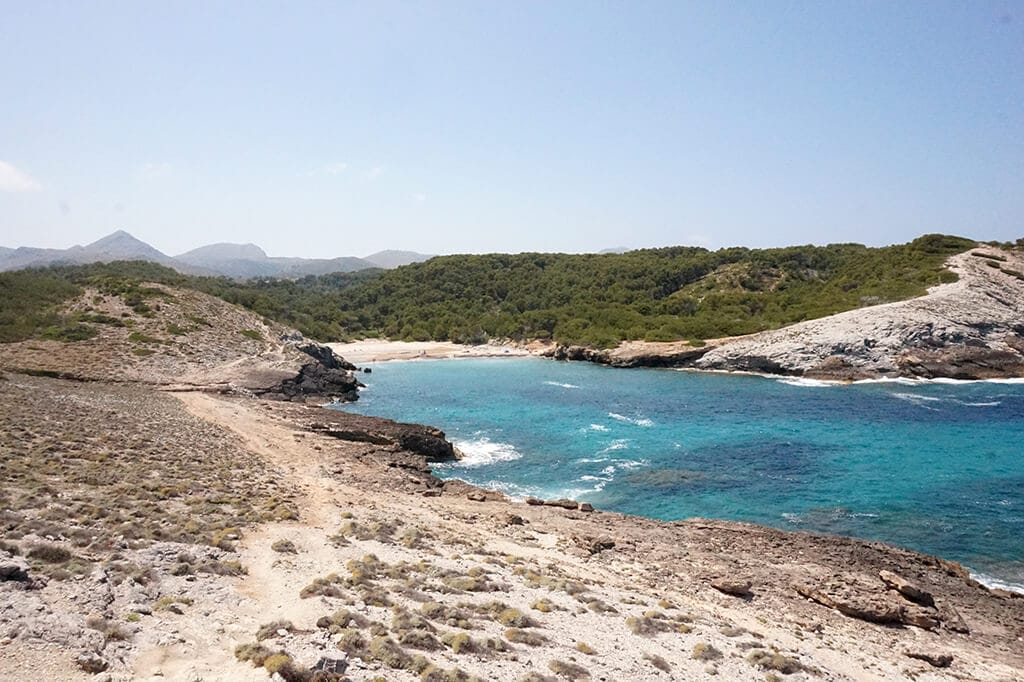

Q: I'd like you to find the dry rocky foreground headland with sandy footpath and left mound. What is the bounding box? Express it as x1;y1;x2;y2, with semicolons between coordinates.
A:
0;278;1024;682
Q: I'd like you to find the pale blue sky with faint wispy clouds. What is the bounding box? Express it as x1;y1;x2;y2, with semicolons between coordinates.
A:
0;0;1024;257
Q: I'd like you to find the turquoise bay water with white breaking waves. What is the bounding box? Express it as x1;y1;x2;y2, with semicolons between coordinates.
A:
331;358;1024;586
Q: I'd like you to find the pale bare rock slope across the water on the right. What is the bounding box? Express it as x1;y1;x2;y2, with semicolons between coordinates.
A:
695;247;1024;378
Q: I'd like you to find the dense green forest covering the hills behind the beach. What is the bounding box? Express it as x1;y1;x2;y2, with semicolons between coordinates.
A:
0;235;975;347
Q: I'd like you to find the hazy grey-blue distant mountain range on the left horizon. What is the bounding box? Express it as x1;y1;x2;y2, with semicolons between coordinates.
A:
0;229;432;280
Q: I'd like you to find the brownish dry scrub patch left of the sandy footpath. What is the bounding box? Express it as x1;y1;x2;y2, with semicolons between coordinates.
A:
0;376;297;552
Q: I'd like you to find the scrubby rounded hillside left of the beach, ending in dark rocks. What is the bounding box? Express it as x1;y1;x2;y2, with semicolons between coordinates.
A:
0;273;357;399
